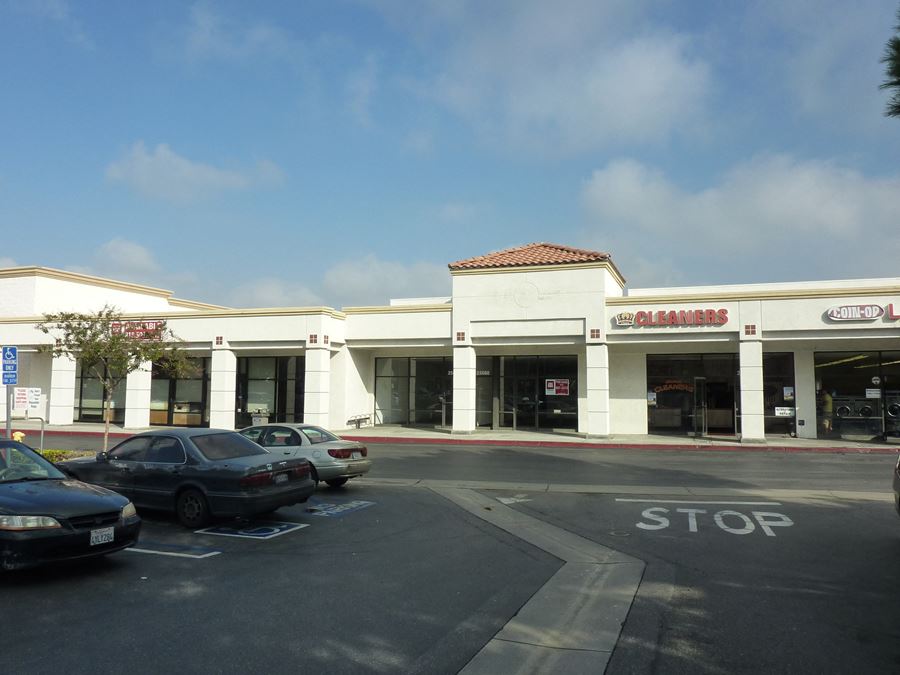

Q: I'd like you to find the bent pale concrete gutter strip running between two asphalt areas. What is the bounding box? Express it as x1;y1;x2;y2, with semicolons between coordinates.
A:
432;487;645;675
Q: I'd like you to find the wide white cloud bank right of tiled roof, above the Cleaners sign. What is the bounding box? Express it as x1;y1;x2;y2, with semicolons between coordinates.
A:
582;155;900;285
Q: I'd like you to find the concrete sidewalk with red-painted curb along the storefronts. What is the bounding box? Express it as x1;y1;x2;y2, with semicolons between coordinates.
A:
0;419;900;453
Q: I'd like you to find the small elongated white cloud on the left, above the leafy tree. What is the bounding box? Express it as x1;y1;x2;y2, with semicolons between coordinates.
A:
106;141;283;202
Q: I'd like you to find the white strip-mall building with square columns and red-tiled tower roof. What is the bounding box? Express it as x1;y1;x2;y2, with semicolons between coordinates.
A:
0;243;900;442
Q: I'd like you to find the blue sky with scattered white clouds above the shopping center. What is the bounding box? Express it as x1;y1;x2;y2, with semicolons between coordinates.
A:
0;0;900;307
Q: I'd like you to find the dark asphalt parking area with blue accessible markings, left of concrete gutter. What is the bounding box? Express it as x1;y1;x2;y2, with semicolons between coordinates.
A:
0;483;560;673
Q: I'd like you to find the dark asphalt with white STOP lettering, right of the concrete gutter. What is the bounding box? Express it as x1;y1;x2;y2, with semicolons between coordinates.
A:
482;490;900;675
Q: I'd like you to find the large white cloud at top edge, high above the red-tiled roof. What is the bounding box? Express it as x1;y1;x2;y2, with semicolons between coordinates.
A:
370;0;710;153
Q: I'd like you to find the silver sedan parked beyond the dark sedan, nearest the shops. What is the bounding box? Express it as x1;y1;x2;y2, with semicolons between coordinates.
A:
240;422;372;487
